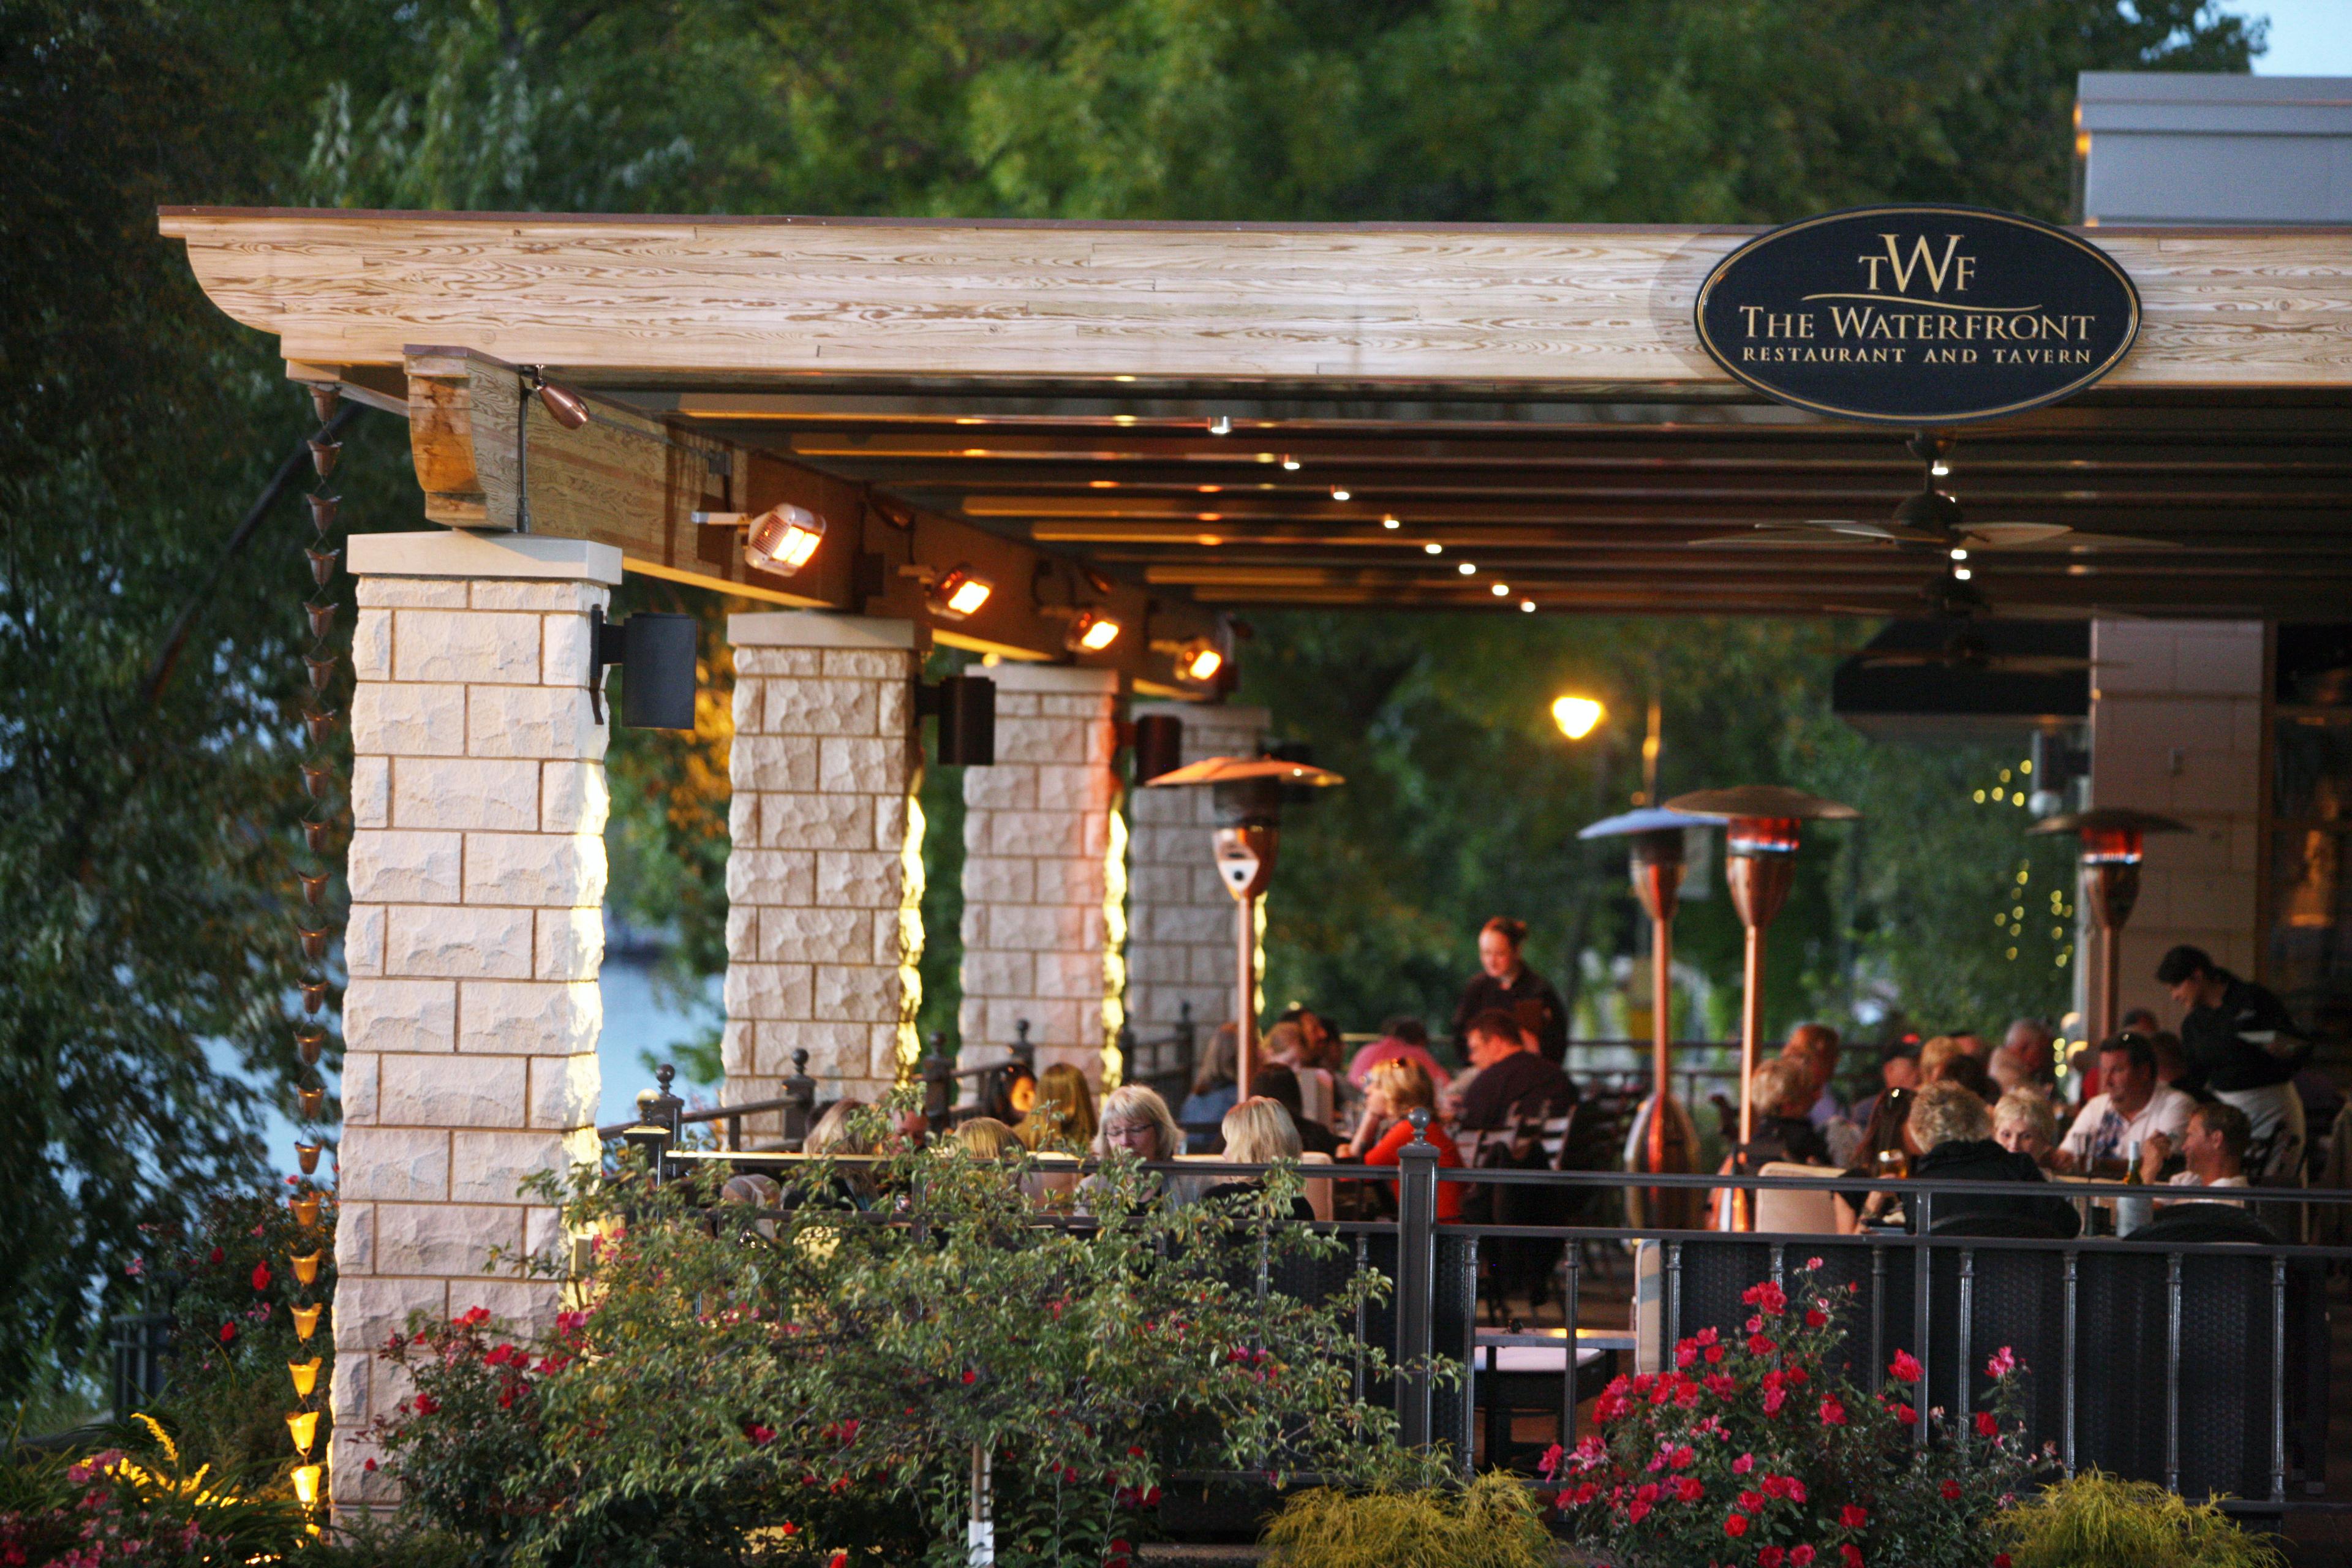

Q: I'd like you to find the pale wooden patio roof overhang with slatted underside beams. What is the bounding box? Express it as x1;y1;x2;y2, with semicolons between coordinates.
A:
162;209;2352;663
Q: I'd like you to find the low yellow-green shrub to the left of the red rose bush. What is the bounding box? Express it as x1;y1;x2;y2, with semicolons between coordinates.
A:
1265;1474;1559;1568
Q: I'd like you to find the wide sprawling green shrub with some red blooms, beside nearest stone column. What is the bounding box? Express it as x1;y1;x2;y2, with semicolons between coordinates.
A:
383;1104;1419;1568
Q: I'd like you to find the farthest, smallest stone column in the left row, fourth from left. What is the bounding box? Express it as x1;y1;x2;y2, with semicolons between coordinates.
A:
1126;703;1268;1053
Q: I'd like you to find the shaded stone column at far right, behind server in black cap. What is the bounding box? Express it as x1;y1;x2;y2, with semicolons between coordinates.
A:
2077;620;2263;1020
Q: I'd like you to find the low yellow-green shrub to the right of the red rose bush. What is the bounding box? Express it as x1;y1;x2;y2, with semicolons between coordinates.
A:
1999;1469;2286;1568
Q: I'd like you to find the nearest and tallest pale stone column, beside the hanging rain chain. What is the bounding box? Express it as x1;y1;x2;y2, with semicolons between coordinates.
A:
330;529;621;1509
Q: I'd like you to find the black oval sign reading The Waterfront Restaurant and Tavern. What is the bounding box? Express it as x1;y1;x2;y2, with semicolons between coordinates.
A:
1696;207;2140;426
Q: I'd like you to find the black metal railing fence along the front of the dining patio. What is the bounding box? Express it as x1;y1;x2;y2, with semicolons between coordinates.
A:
614;1072;2352;1514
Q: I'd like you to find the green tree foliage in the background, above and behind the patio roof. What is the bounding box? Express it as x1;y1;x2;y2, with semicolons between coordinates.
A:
0;0;2260;1392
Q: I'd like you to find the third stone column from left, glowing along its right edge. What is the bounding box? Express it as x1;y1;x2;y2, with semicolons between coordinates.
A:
957;663;1126;1086
